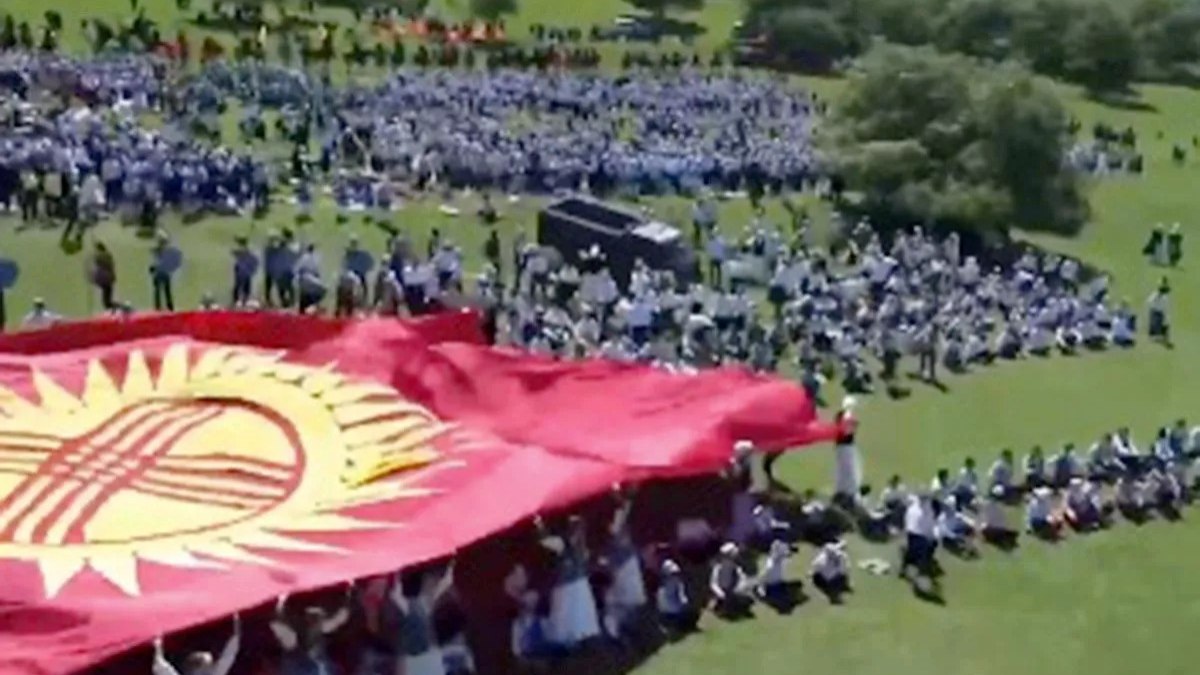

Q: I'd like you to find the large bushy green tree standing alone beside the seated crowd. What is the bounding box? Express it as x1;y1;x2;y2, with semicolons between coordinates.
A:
823;44;1087;238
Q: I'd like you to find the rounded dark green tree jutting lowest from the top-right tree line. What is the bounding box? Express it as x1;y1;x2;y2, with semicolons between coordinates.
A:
1067;1;1139;94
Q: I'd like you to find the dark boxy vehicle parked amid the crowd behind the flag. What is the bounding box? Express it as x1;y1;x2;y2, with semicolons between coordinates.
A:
538;197;698;288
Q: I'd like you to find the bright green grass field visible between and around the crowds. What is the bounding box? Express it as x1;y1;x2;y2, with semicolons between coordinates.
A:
7;0;1200;675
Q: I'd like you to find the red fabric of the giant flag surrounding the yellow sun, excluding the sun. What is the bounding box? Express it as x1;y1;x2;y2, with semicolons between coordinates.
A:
0;313;836;674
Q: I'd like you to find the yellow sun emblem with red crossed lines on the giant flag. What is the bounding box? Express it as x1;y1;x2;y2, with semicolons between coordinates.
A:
0;346;448;597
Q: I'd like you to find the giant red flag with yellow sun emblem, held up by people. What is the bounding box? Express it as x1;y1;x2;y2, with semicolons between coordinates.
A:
0;313;833;674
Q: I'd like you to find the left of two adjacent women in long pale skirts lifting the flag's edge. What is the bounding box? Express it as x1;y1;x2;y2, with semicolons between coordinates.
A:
536;515;600;649
